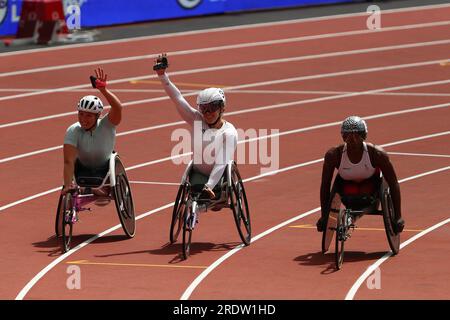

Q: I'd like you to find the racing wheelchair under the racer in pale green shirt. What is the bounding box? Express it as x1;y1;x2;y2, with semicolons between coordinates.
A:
55;152;136;253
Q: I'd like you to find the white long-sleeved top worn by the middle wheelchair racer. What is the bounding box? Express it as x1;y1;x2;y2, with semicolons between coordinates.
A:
159;74;238;189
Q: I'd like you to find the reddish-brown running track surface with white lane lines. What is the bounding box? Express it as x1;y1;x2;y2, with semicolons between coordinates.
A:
0;3;450;299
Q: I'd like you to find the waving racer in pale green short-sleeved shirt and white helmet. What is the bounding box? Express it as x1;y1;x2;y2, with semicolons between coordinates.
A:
61;68;122;194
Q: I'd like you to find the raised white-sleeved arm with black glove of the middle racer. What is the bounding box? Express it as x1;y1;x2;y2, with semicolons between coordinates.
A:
154;55;201;125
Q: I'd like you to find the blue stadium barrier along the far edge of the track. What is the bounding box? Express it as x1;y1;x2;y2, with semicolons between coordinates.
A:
0;0;362;36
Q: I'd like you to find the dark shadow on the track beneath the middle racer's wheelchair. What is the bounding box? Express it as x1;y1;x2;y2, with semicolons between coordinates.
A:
96;242;240;263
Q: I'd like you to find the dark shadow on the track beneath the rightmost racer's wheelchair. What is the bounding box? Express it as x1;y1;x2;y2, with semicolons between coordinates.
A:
294;251;386;274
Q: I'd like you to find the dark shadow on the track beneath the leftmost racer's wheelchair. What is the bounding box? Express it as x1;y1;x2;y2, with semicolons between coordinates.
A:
33;234;128;257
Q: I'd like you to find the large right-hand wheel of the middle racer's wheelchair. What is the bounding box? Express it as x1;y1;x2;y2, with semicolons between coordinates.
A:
228;163;252;246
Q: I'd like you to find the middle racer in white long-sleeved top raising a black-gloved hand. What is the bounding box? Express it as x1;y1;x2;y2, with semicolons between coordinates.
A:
153;54;237;199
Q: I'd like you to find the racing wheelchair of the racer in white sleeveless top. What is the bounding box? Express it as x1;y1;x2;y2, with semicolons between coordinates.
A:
322;173;400;270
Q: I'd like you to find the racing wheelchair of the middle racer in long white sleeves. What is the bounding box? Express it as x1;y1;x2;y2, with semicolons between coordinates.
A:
170;160;251;259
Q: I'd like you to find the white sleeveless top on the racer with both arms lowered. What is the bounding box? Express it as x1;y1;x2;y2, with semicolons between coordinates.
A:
338;142;375;182
